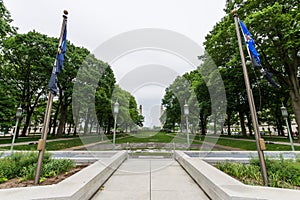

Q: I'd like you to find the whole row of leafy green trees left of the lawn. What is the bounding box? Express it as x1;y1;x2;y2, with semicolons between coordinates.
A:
0;1;143;136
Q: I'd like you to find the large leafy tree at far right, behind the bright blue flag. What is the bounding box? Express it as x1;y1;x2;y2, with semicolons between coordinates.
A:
231;0;300;139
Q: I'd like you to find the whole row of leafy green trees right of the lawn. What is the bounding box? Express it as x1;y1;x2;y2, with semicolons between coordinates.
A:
162;0;300;140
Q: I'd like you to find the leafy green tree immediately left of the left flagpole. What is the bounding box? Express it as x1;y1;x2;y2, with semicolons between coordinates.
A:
2;31;57;136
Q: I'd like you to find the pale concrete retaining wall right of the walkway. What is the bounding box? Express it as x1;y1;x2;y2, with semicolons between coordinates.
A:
175;151;300;200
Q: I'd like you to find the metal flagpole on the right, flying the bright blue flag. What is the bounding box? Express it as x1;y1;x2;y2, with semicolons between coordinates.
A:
232;9;268;186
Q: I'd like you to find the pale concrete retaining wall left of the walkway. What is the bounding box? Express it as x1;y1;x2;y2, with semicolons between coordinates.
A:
0;151;127;200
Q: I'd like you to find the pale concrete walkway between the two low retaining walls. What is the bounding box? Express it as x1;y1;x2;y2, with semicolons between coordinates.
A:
91;159;209;200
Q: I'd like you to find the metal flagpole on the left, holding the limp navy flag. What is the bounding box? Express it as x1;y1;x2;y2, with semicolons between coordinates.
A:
34;10;68;185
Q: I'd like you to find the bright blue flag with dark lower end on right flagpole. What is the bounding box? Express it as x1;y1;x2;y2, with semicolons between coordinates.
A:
239;19;278;87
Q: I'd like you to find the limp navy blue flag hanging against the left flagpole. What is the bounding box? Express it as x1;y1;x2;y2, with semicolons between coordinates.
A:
48;24;67;95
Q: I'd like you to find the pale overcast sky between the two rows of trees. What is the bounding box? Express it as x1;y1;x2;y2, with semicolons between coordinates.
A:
4;0;225;126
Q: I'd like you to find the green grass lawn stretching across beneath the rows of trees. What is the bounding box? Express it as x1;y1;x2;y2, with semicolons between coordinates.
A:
0;131;300;151
